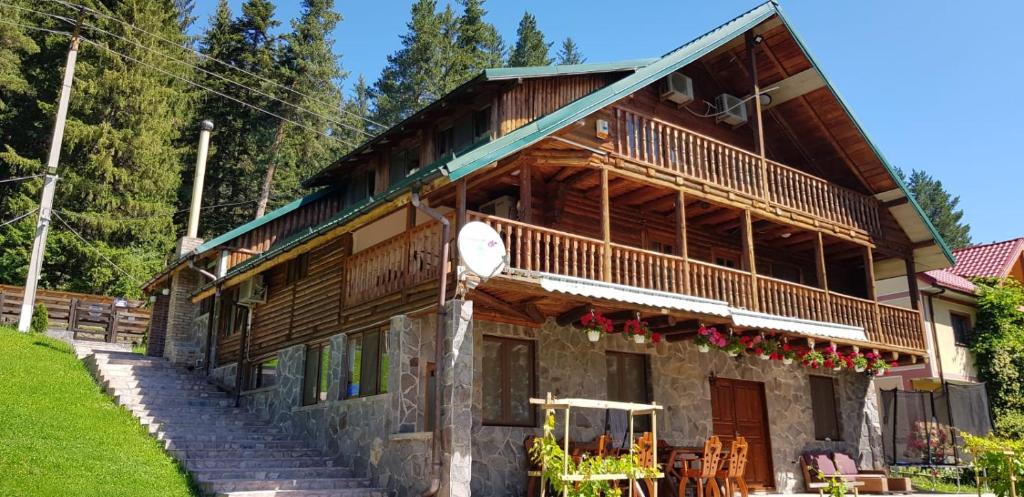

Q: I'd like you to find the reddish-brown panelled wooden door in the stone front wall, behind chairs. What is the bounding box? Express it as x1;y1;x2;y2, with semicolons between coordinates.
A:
711;378;775;489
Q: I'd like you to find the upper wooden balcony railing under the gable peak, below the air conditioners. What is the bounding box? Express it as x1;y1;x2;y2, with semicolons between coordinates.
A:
614;108;881;235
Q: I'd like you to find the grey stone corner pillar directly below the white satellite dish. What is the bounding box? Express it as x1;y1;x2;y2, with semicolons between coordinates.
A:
438;300;473;497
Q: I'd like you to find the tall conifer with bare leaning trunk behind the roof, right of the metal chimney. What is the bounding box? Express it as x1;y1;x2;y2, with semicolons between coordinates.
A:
256;0;350;217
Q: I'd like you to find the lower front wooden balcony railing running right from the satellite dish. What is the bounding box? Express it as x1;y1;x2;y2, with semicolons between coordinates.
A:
469;213;925;350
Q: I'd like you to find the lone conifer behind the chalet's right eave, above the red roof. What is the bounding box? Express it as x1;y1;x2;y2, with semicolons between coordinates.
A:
897;169;971;249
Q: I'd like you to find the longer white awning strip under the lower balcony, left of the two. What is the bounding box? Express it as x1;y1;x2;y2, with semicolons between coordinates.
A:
531;273;729;317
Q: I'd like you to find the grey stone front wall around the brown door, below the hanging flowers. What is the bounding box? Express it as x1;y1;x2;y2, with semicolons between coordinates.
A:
472;320;883;495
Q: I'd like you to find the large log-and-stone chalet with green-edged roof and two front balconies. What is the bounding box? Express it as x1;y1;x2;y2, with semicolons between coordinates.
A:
145;3;952;495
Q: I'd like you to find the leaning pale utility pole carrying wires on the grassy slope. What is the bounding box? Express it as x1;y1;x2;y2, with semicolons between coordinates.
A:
17;8;85;332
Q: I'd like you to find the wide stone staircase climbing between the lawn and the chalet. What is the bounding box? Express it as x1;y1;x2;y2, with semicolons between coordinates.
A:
84;349;388;497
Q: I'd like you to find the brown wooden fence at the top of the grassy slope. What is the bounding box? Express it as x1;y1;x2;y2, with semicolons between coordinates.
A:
0;285;151;343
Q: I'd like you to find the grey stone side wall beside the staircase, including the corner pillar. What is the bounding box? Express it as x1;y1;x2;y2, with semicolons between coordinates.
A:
224;301;473;497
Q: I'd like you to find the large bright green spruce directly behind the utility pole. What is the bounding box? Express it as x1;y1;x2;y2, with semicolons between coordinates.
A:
0;2;193;296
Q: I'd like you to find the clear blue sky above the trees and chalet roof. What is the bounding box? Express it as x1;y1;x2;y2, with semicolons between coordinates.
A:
196;0;1024;243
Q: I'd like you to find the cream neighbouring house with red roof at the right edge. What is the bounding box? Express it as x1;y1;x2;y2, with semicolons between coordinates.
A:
876;238;1024;390
